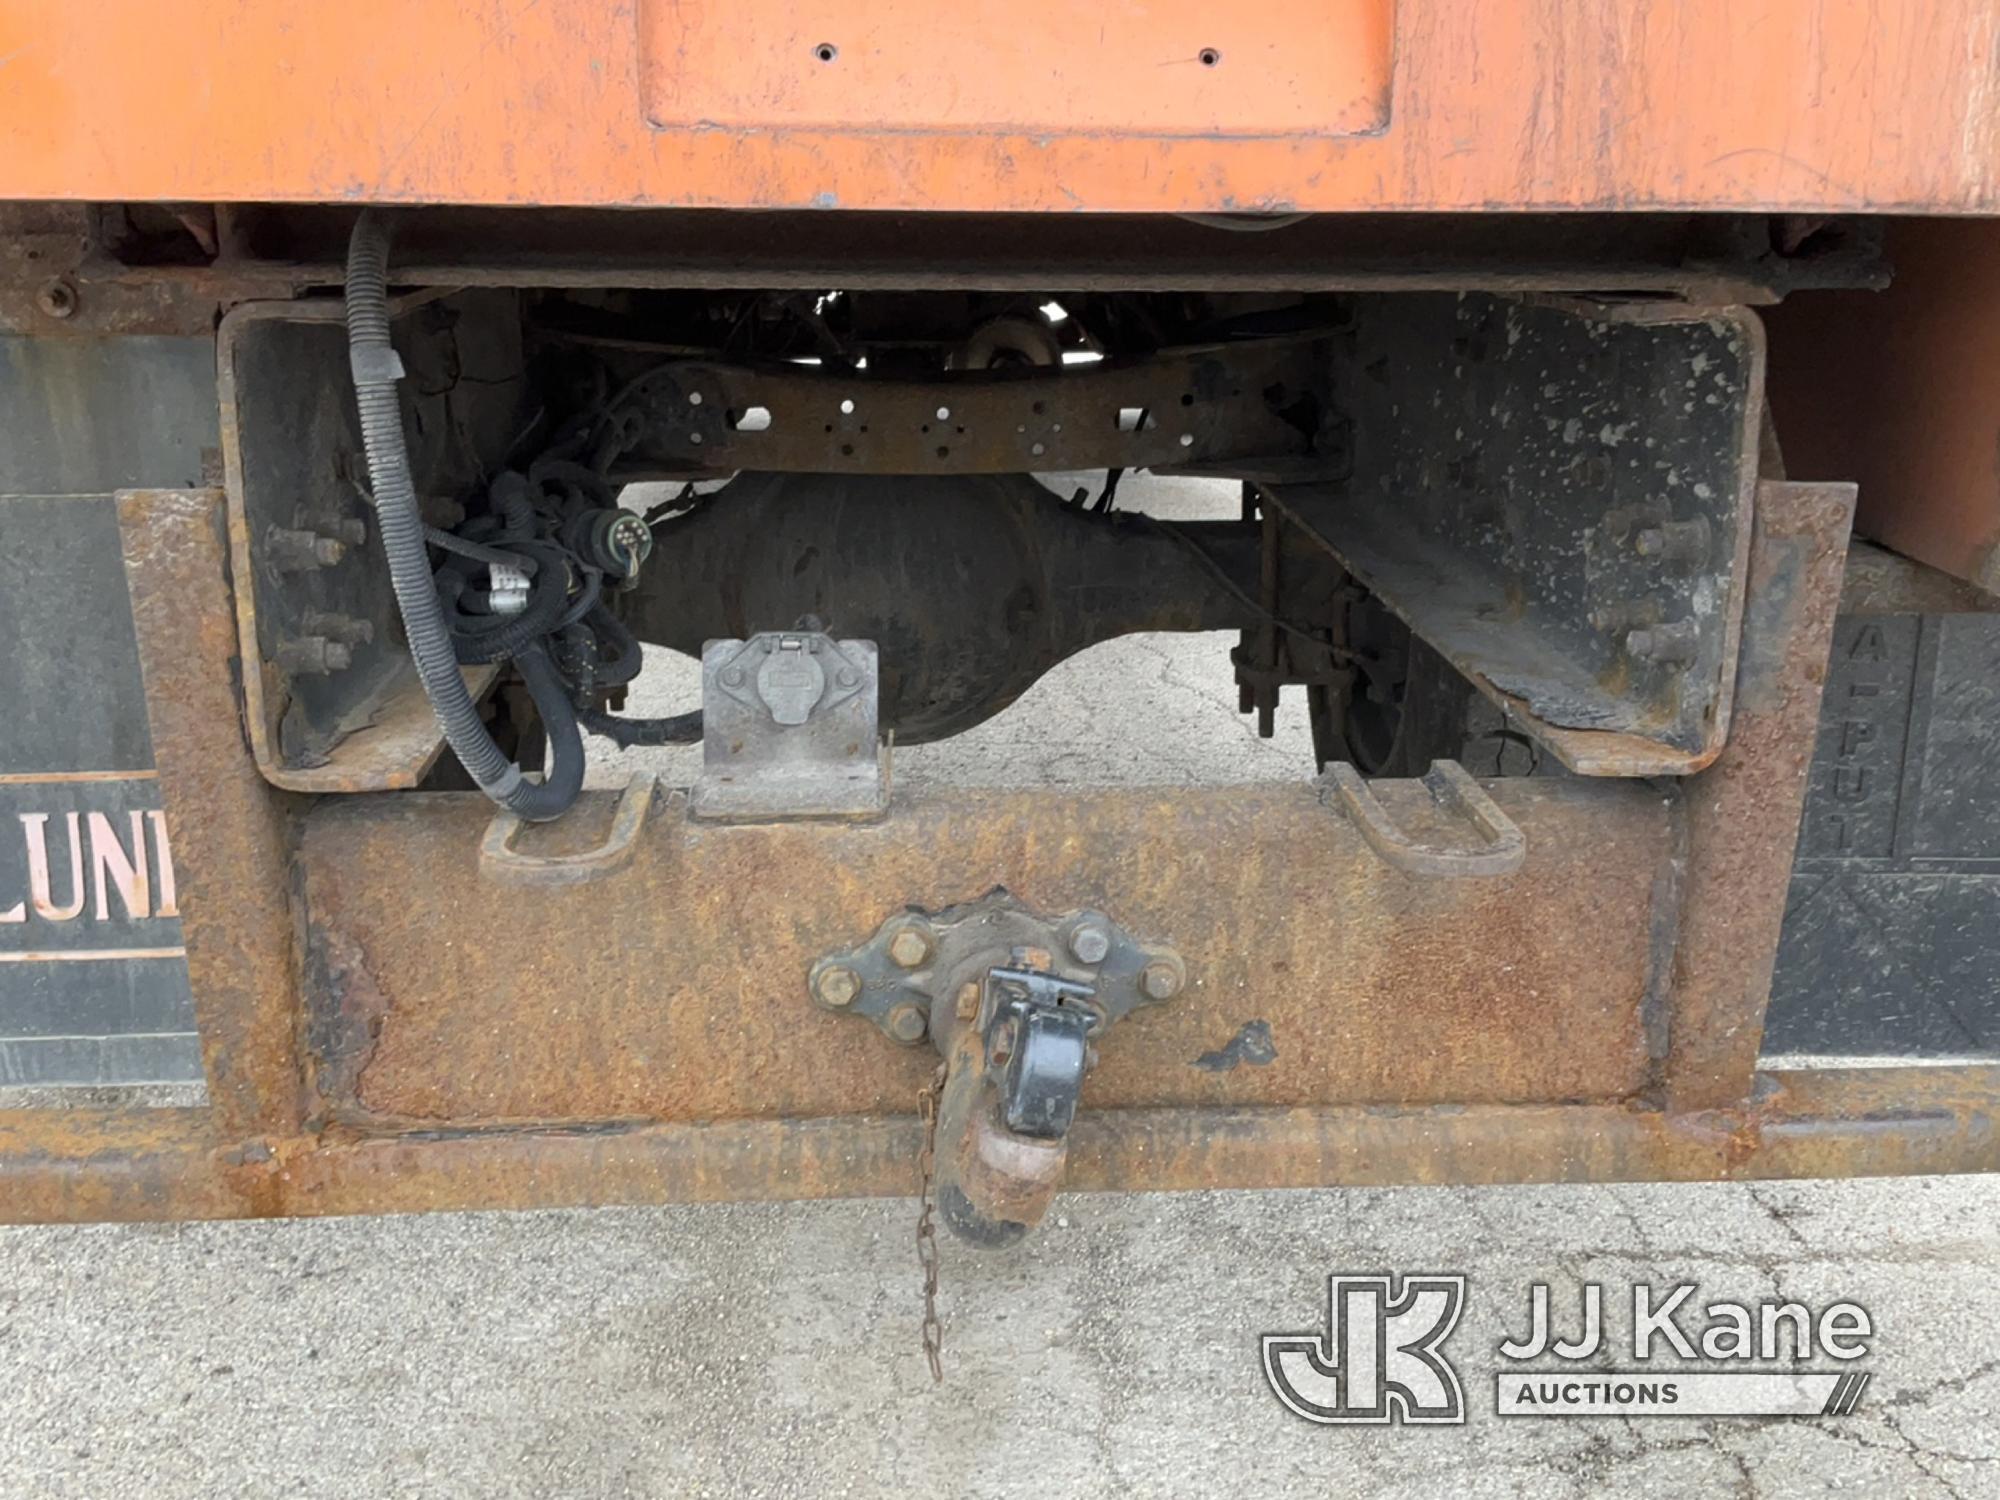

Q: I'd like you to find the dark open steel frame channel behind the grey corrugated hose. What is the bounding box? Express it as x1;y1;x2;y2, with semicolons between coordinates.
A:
216;290;524;792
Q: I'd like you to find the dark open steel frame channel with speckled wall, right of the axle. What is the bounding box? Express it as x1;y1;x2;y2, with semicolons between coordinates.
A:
1260;294;1764;776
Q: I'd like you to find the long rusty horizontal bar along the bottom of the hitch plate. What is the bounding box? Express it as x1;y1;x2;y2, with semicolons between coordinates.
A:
0;1066;2000;1222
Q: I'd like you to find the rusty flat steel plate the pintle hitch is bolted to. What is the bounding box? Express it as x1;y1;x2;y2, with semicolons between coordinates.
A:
298;780;1668;1126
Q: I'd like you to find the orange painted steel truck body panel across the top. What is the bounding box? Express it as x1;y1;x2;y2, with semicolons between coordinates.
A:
0;0;2000;214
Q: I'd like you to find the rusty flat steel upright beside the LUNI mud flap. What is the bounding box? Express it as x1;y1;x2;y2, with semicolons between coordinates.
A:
118;490;304;1140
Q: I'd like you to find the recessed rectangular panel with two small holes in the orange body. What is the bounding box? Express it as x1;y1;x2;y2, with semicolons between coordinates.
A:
638;0;1394;138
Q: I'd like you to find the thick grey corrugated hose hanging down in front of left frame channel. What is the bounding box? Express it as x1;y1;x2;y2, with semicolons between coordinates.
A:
346;208;582;822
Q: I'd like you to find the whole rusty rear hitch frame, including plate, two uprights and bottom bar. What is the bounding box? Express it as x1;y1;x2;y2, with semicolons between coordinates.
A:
0;482;2000;1222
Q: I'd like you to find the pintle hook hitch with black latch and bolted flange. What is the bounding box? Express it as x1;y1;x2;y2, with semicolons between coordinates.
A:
808;890;1188;1246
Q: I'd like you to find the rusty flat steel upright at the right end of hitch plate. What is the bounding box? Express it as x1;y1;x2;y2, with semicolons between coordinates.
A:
1666;480;1854;1110
